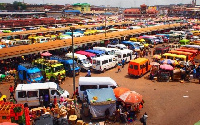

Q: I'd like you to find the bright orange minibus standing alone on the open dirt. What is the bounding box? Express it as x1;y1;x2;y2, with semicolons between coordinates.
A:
128;58;151;77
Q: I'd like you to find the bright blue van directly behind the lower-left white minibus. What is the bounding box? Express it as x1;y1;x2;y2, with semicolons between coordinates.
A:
17;63;43;83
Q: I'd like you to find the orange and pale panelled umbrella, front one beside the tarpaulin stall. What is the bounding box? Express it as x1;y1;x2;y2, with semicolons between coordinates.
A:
119;91;142;104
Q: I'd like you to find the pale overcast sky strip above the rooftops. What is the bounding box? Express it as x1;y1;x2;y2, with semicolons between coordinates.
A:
0;0;200;8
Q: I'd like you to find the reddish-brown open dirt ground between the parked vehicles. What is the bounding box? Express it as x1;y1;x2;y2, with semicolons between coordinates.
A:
0;46;200;125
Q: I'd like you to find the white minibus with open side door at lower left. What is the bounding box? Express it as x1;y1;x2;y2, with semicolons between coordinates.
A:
15;82;69;106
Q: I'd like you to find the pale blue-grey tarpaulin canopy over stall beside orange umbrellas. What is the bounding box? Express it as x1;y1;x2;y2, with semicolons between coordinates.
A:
86;88;116;118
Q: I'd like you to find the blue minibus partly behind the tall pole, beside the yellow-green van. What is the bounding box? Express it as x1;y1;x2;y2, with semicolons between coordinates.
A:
50;56;80;76
